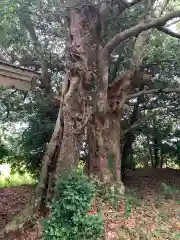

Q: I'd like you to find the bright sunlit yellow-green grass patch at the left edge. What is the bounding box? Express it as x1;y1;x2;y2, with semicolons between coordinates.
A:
0;173;35;188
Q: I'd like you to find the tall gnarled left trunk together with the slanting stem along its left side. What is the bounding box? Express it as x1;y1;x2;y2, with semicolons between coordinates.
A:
37;0;100;198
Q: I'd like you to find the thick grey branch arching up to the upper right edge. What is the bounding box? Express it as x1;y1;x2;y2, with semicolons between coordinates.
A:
103;11;180;58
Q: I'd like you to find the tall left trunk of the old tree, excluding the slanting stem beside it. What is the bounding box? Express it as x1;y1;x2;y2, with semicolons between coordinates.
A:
56;0;100;176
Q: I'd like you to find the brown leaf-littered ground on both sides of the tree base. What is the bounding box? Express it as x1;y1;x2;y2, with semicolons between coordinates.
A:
0;169;180;240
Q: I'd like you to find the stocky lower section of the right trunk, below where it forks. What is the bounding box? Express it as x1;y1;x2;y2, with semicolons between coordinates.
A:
89;113;121;183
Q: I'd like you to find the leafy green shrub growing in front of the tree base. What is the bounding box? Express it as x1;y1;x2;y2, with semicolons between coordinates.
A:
42;163;104;240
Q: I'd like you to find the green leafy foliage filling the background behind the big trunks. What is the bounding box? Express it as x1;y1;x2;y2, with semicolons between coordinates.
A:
0;0;180;178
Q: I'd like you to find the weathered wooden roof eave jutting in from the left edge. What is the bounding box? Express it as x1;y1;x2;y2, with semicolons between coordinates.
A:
0;62;40;91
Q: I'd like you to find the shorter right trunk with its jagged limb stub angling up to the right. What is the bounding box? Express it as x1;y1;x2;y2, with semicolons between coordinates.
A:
90;72;132;184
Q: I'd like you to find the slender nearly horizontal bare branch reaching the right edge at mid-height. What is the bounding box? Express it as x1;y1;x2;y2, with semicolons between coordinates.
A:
126;88;180;100
